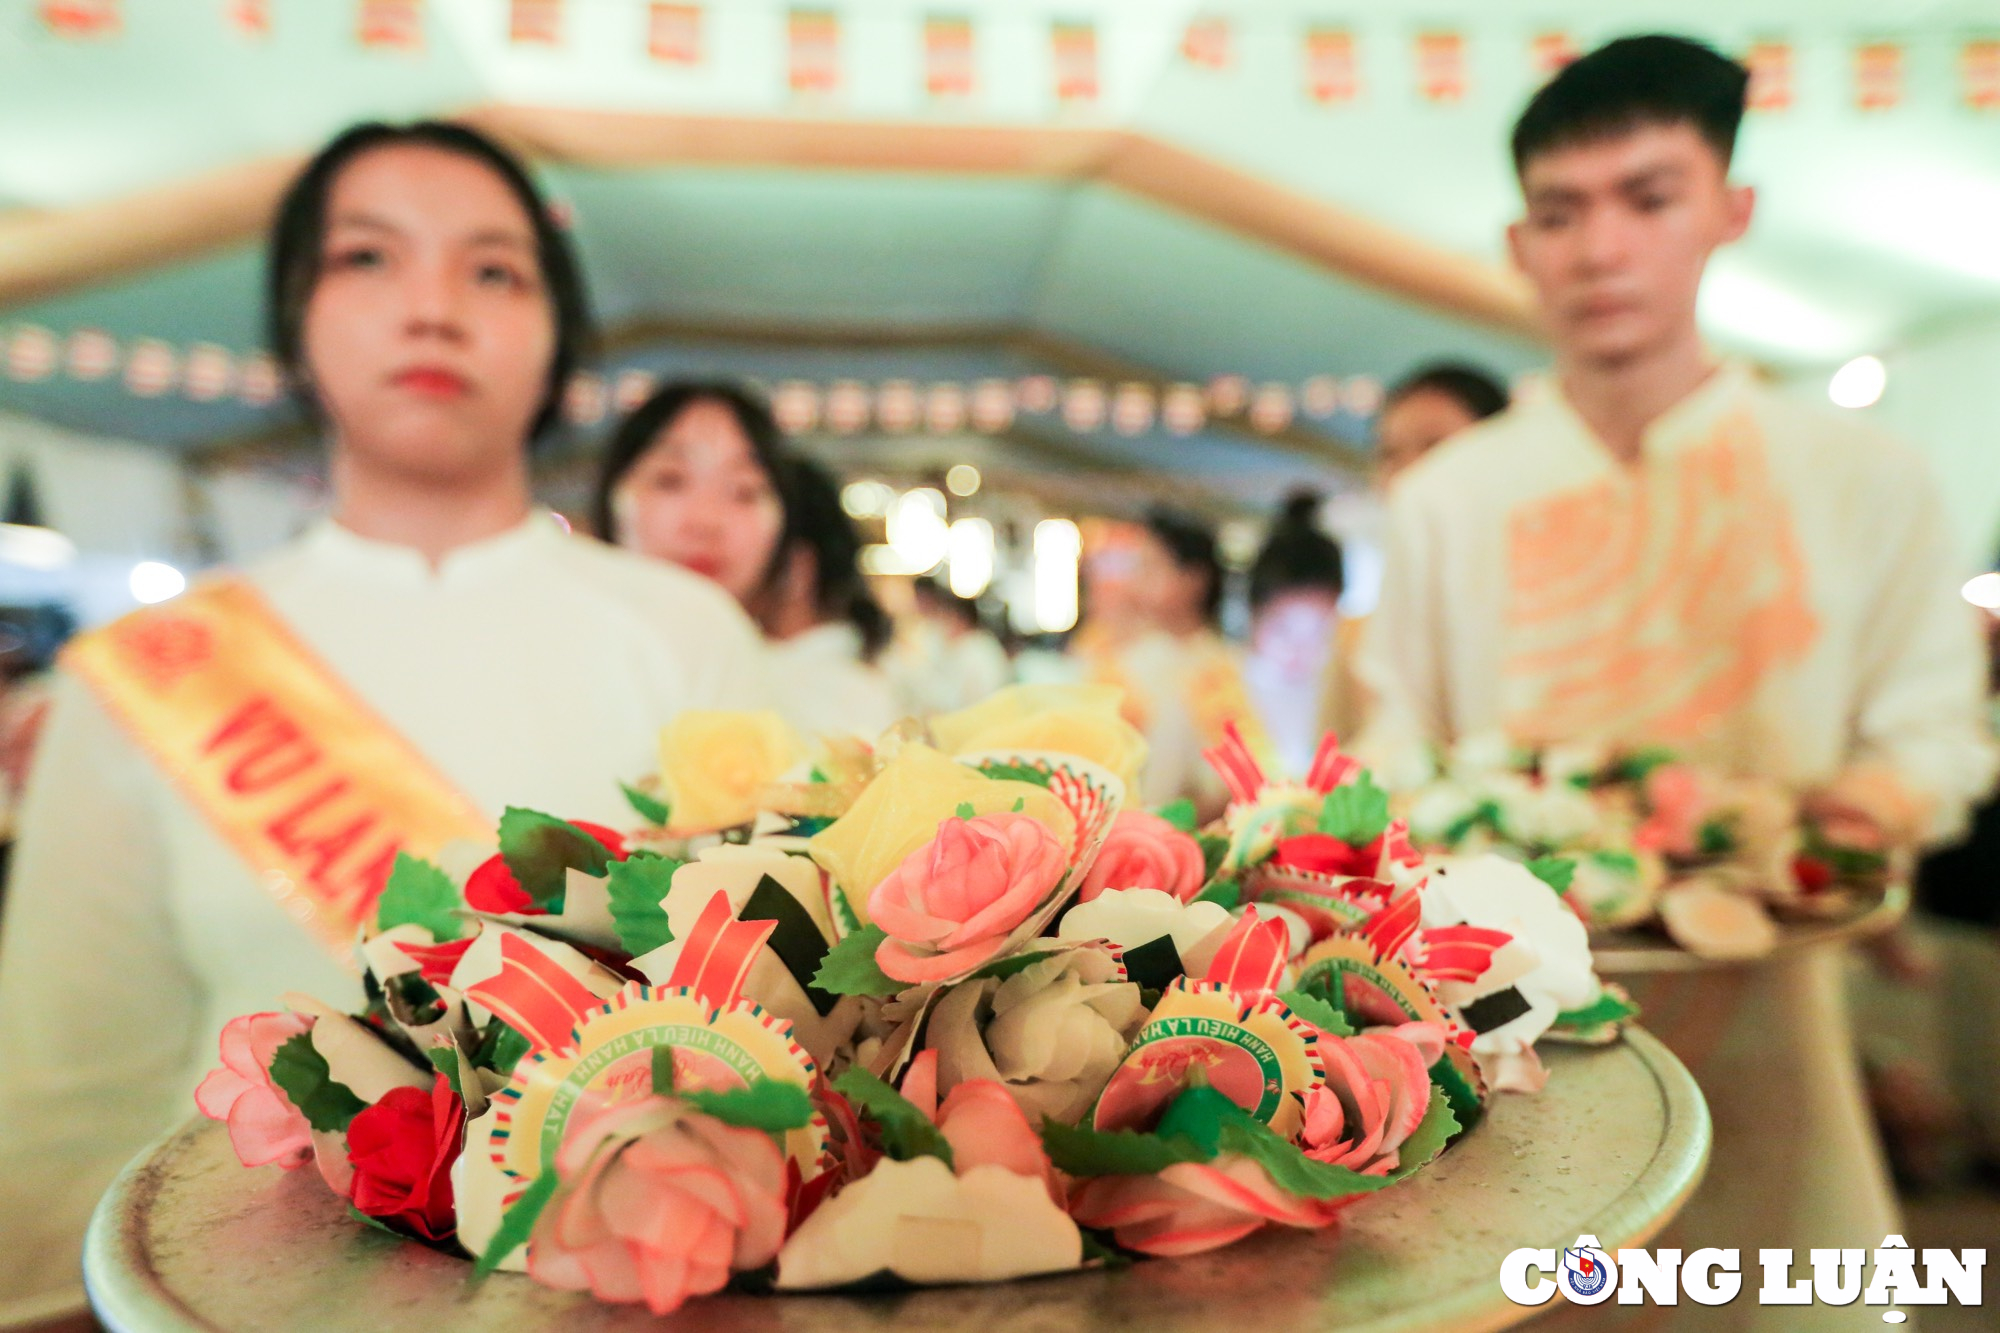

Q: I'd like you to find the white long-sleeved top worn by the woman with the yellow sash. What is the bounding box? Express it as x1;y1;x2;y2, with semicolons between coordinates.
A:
0;512;768;1323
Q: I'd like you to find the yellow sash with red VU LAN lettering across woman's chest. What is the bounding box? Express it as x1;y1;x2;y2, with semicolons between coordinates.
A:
64;578;492;963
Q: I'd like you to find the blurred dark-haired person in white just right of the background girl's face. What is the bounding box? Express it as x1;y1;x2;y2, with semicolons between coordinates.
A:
762;456;902;739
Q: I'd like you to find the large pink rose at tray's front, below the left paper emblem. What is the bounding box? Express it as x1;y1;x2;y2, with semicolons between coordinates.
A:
528;1097;786;1315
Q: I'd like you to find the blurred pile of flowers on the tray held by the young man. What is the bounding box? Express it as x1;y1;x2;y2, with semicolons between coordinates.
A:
1396;737;1920;961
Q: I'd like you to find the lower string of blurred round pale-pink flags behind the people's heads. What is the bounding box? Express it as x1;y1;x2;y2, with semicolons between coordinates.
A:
0;324;1382;436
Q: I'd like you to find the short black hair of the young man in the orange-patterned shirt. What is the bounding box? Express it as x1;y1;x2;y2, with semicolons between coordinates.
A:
1514;32;1750;174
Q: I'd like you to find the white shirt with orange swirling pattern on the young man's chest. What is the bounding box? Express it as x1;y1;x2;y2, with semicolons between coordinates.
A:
1362;366;1994;835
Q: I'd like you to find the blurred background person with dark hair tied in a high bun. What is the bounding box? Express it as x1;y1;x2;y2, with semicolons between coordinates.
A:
1244;490;1360;775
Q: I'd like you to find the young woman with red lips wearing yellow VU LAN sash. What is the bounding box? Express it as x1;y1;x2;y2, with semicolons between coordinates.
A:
0;122;764;1323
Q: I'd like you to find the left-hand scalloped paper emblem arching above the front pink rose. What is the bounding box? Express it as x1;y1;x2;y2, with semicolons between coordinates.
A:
492;983;826;1181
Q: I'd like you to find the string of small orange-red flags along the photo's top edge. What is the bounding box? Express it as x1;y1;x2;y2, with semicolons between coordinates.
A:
26;0;2000;112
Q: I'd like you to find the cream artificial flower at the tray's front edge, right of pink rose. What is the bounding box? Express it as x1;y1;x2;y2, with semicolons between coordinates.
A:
778;1149;1084;1291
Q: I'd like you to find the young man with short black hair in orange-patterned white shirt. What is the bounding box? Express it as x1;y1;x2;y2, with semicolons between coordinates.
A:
1364;36;1994;1253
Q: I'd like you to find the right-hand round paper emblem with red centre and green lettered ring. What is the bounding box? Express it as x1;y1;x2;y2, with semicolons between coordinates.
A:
1092;979;1322;1133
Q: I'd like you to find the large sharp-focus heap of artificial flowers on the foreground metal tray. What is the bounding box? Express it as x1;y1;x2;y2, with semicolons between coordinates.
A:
198;687;1632;1313
